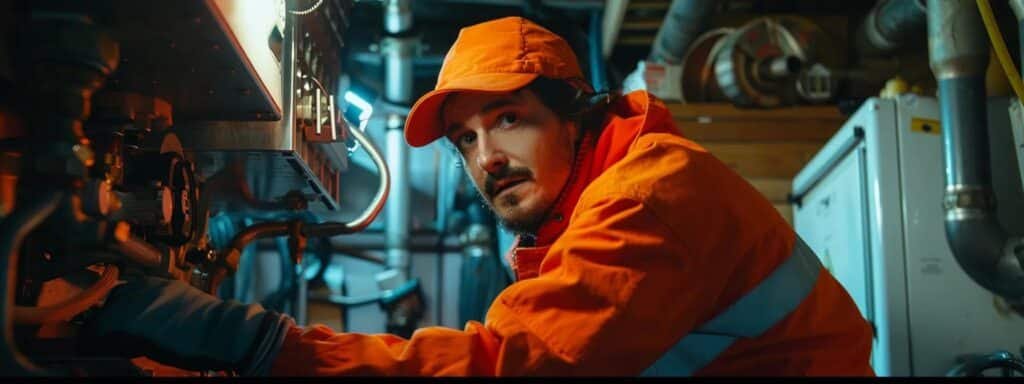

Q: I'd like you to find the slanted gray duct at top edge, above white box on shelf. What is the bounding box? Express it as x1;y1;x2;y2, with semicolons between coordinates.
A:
647;0;715;63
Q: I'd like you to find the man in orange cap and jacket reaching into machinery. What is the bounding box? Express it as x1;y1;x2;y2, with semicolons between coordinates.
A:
88;17;872;376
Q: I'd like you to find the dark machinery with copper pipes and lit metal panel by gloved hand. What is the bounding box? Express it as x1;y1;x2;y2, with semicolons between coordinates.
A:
0;0;409;376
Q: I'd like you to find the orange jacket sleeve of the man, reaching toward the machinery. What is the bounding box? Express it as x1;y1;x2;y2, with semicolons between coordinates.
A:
271;197;723;376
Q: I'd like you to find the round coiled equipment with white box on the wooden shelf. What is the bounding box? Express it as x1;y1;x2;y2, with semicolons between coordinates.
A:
624;16;842;108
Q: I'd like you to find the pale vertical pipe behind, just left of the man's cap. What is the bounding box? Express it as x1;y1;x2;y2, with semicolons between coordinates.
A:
381;0;419;282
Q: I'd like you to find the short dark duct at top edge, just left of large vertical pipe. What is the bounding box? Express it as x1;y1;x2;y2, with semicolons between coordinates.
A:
856;0;928;56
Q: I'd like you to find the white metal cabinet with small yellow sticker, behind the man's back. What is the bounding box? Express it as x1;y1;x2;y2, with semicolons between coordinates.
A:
793;95;1024;376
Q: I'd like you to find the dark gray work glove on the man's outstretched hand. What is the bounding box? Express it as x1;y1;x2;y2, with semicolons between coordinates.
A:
79;276;295;376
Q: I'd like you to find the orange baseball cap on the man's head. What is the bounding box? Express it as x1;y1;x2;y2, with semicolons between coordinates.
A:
406;17;590;146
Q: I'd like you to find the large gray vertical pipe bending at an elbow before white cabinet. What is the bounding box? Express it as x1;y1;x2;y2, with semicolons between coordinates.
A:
928;0;1024;301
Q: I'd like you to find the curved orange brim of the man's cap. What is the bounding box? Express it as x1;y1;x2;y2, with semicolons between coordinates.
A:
406;73;540;146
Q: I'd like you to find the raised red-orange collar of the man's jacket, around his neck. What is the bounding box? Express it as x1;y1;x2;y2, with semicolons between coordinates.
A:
508;91;673;280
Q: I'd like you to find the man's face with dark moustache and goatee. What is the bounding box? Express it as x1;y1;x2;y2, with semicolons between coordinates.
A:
441;89;578;233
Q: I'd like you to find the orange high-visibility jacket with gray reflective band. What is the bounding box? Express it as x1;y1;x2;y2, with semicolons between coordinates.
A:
271;91;873;376
